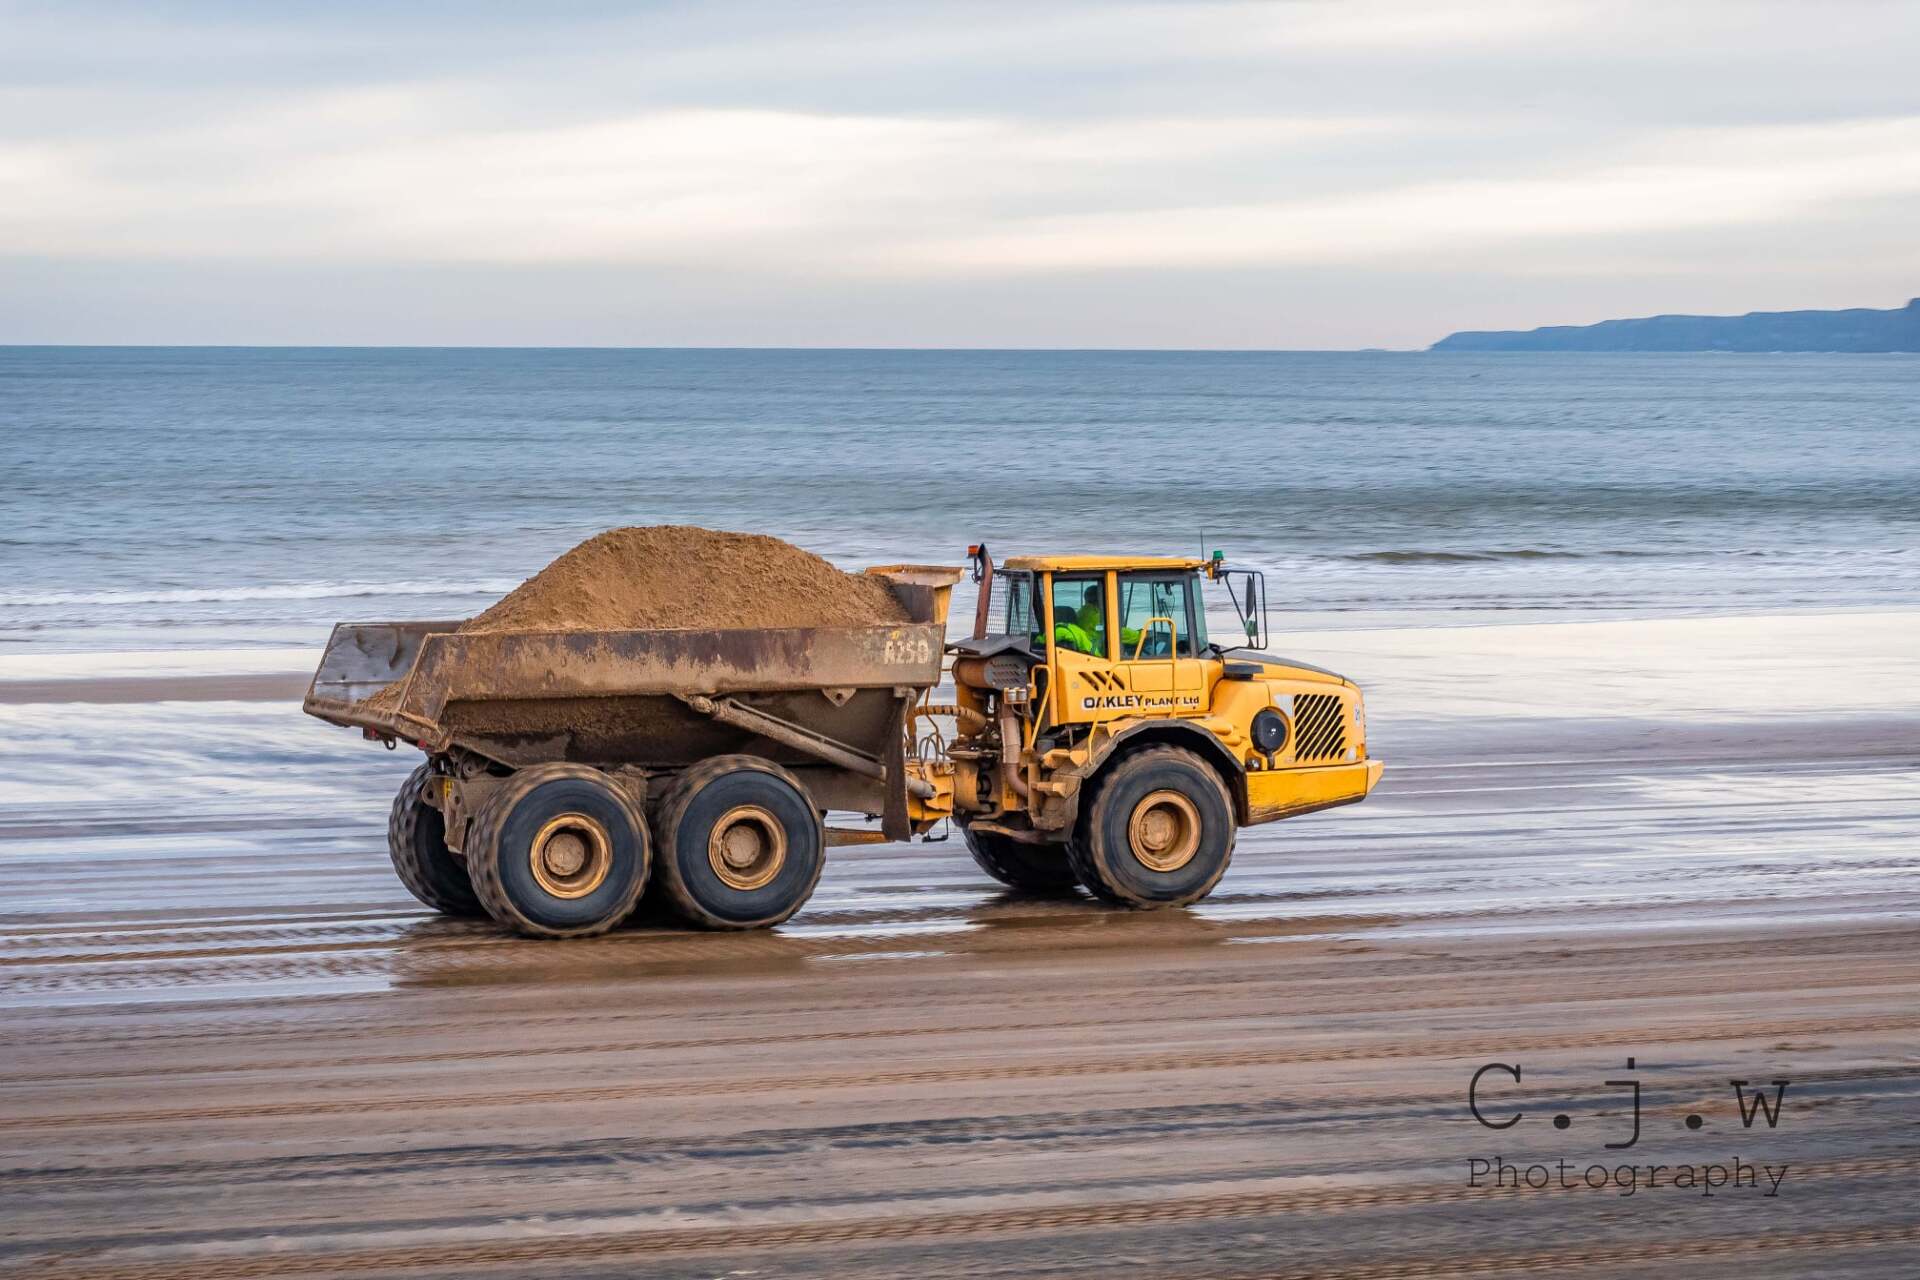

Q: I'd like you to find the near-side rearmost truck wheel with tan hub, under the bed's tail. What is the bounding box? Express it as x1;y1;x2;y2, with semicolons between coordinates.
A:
467;764;651;938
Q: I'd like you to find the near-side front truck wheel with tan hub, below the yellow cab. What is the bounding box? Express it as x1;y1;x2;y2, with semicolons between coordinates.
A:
1068;747;1235;908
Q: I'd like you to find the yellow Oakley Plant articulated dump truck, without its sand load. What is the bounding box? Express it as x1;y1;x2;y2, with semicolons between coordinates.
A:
305;547;1380;938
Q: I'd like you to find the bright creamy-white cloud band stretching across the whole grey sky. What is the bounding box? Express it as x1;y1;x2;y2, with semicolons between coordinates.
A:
15;90;1920;284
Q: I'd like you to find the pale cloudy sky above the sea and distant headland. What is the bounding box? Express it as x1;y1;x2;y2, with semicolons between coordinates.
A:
0;0;1920;349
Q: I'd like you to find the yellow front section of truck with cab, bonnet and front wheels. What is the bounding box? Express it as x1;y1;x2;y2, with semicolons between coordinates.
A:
925;549;1382;906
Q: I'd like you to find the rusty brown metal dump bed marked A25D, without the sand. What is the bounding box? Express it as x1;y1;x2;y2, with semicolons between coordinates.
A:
305;566;958;768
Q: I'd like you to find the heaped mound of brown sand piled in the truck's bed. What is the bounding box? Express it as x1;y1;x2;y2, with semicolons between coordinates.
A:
461;524;906;631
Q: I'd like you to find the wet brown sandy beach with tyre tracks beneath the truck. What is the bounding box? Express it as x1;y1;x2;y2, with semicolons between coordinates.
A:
0;614;1920;1278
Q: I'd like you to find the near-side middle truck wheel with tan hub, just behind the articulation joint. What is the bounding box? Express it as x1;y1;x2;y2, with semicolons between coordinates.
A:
653;756;828;929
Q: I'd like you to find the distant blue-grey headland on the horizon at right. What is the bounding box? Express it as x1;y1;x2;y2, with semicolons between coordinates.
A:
1430;297;1920;351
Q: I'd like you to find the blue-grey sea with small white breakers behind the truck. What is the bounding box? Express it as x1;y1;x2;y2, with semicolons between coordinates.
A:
0;347;1920;654
